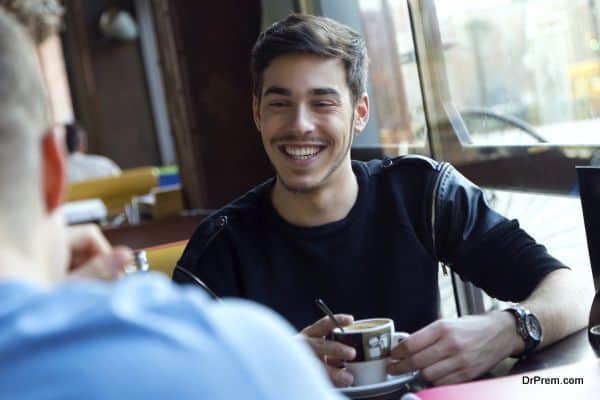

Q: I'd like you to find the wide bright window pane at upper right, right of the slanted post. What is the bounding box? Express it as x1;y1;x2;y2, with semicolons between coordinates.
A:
435;0;600;145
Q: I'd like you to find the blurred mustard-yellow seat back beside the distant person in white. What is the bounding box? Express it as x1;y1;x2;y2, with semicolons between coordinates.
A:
67;167;160;215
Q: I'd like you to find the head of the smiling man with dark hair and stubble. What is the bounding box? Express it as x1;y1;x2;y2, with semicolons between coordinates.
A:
252;15;369;193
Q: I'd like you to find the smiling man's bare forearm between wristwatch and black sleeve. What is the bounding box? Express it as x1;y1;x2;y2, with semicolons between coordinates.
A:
522;269;594;347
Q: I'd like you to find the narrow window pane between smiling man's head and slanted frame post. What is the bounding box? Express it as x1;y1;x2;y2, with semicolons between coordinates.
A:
357;0;426;154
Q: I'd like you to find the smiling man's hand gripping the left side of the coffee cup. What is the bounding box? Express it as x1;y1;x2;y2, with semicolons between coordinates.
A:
300;314;356;387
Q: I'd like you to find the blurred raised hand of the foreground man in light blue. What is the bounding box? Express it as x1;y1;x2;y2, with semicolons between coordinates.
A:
67;224;133;280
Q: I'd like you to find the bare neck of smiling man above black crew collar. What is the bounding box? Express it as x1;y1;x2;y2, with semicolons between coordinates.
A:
271;163;358;227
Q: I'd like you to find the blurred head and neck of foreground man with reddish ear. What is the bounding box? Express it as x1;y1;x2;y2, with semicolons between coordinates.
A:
0;8;66;275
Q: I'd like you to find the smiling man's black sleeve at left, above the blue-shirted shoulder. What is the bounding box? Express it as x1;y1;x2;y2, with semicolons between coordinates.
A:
173;215;240;297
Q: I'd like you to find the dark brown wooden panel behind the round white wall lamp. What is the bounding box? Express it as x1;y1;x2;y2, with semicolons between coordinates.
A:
63;0;160;168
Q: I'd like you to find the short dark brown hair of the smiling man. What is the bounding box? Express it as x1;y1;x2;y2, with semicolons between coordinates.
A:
250;14;368;102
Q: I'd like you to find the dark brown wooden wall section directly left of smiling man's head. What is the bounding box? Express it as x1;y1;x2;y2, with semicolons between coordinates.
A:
153;0;273;209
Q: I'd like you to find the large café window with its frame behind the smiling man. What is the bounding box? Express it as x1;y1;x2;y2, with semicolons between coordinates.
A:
319;0;600;316
